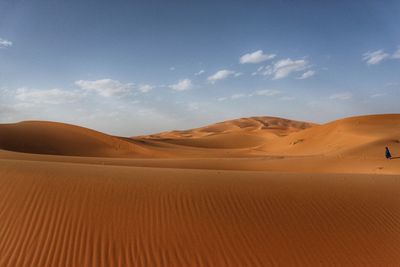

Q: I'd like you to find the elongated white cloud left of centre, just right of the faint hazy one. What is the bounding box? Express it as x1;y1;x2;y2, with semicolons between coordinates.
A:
75;79;133;97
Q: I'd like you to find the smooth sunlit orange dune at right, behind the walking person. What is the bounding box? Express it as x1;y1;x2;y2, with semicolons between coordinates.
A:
260;114;400;157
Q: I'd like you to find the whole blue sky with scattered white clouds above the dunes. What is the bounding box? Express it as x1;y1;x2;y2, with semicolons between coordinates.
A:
0;0;400;136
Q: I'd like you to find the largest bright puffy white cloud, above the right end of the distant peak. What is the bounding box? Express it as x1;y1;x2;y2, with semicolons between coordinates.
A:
270;58;308;80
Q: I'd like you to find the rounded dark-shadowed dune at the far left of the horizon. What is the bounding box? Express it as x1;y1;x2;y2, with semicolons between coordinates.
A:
0;121;156;157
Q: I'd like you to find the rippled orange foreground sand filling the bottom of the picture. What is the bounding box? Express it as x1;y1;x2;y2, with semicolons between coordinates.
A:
0;159;400;267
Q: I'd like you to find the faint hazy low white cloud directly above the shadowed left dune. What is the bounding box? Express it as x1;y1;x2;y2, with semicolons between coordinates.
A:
15;88;81;105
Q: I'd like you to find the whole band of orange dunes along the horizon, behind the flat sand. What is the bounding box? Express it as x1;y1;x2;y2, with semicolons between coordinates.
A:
0;114;400;162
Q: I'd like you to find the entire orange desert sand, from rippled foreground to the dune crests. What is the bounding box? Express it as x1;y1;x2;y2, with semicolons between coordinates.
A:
0;114;400;267
